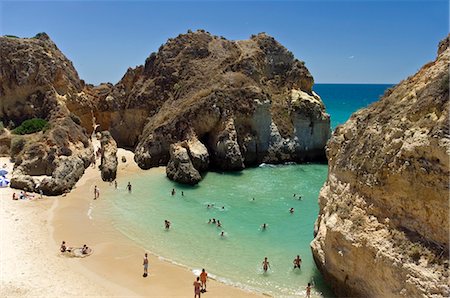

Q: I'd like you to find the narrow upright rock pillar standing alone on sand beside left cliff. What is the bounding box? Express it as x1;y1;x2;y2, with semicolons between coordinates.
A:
100;131;117;181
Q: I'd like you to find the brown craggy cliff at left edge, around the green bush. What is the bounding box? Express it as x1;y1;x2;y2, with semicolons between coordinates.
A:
0;33;93;195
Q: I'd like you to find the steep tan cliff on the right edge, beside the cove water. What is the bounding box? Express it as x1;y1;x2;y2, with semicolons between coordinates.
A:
311;37;450;297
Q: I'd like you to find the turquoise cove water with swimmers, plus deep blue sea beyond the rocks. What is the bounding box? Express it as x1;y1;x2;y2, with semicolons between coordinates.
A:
92;84;390;297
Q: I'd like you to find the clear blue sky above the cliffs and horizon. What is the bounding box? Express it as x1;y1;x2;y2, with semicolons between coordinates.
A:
0;0;449;84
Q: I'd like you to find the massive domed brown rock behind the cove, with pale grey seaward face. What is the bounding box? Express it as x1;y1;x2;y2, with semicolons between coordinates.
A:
96;30;330;184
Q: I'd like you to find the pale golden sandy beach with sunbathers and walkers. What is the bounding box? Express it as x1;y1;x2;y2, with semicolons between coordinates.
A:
0;149;261;297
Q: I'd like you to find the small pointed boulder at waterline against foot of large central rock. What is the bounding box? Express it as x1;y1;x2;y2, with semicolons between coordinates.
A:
166;144;202;185
